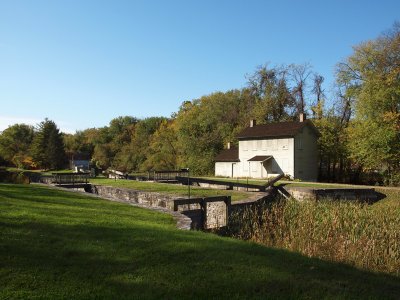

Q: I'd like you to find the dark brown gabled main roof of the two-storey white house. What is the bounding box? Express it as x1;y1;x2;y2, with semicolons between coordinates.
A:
237;120;319;139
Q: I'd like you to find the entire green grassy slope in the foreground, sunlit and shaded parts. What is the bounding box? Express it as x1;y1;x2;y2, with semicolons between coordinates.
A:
0;184;400;299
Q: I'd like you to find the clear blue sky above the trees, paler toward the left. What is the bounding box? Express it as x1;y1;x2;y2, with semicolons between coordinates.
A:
0;0;400;132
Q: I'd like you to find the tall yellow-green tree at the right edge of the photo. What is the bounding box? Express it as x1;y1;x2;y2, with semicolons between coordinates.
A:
337;23;400;179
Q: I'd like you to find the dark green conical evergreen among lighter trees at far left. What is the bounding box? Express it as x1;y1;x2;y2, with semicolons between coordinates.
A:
31;118;67;169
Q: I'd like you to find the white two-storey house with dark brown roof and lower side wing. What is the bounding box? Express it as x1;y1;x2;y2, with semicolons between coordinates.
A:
215;115;319;181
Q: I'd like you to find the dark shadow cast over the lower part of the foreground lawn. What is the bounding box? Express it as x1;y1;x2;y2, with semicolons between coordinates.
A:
0;222;400;299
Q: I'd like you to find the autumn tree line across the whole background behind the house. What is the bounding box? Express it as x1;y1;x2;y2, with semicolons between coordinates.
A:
0;23;400;184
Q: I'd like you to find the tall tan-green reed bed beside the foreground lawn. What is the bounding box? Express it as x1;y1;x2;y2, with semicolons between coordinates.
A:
228;198;400;276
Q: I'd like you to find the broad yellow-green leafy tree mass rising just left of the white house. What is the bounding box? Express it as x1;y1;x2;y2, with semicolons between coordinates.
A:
175;89;253;174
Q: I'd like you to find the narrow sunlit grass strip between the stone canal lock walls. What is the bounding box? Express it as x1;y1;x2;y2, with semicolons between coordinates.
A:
90;178;254;201
